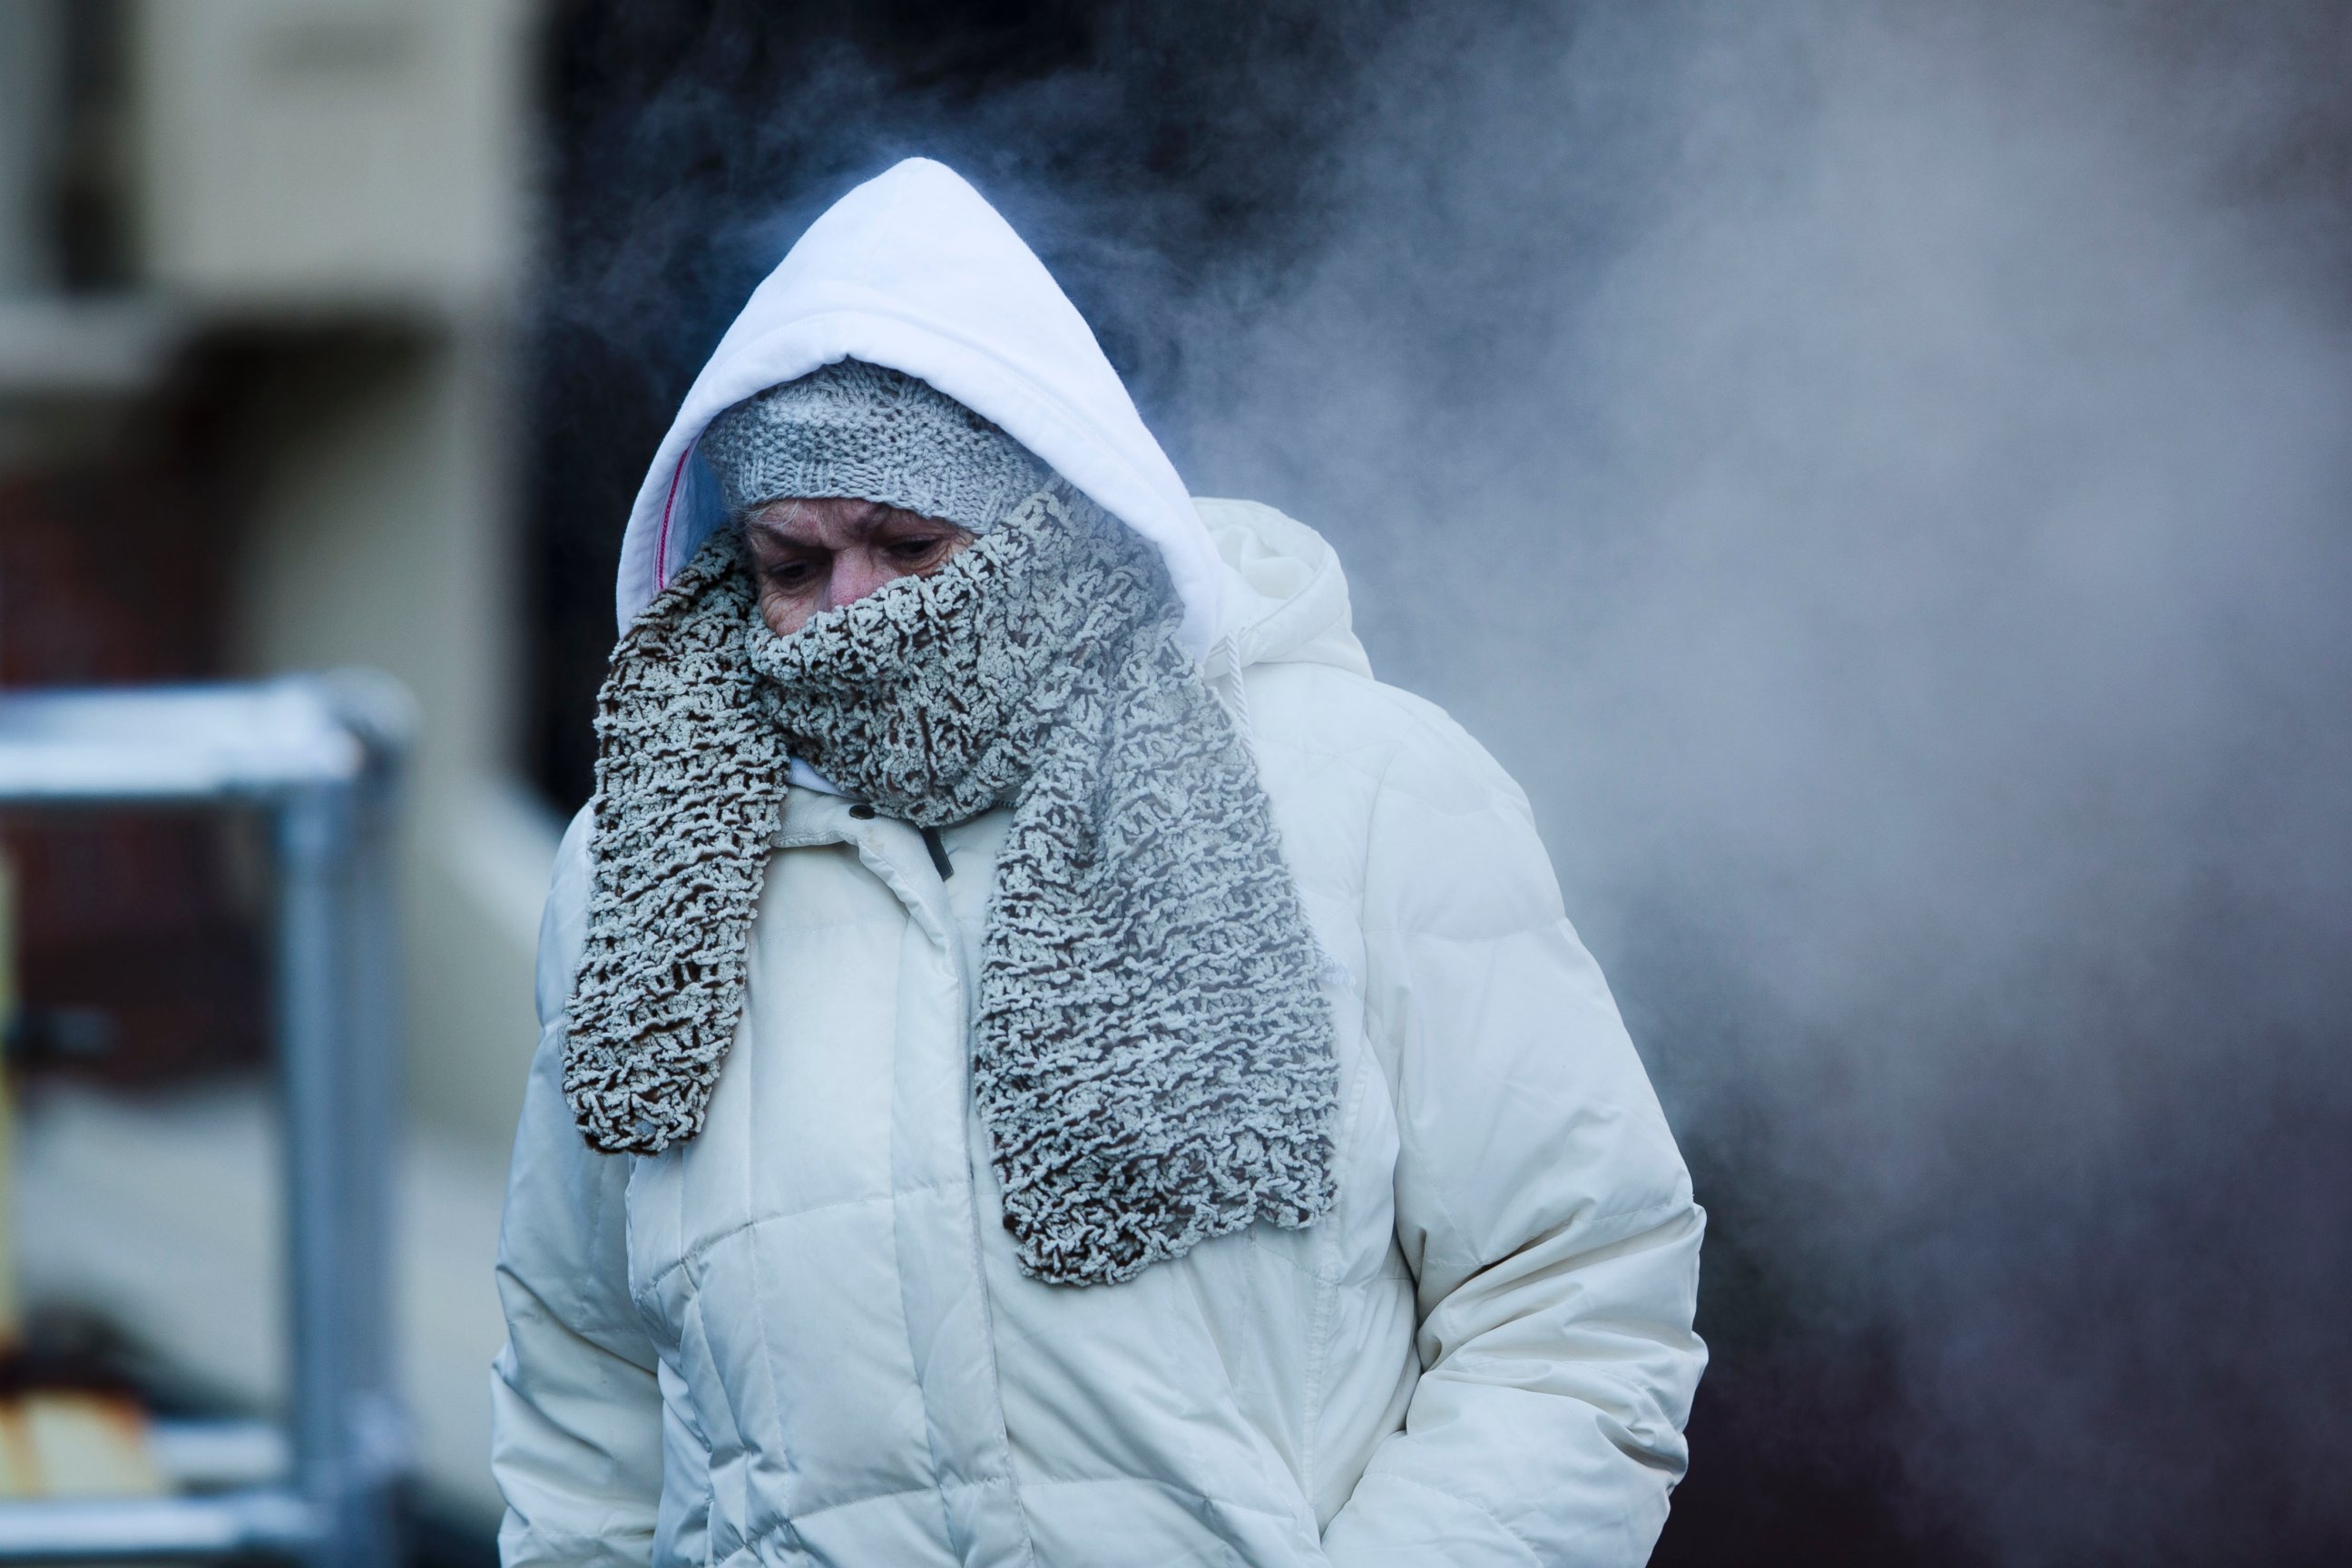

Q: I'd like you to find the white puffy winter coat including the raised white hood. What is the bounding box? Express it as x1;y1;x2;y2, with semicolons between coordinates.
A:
494;160;1705;1568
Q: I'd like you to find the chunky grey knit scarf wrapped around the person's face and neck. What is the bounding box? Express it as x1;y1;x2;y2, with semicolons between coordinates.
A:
564;485;1338;1284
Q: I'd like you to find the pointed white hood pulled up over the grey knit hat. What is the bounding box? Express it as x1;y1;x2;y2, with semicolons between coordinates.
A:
614;158;1228;658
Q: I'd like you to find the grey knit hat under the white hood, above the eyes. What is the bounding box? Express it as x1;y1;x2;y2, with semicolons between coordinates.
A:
701;359;1054;534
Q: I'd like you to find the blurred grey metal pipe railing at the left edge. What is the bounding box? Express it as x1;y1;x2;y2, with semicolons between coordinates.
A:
0;675;414;1565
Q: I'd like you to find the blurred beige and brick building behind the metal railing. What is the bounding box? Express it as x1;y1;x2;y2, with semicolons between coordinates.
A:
0;0;541;1535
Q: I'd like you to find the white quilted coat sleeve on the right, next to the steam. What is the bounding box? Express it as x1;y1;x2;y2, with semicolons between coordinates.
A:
1324;710;1705;1568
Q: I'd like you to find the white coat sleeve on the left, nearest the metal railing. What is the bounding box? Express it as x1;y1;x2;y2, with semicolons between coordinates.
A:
492;813;661;1568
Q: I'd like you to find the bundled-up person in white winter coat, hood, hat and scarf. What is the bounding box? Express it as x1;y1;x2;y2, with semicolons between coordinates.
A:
494;160;1705;1568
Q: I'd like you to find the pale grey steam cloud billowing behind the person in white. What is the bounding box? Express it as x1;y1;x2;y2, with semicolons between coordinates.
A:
541;0;2352;1565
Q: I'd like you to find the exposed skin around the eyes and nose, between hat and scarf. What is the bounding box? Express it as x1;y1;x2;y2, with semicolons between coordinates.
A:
743;498;971;637
